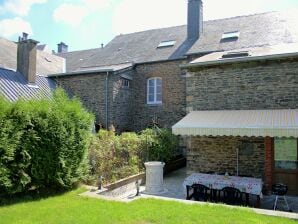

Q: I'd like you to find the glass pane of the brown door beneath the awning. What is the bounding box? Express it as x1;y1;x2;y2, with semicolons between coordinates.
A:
274;138;298;169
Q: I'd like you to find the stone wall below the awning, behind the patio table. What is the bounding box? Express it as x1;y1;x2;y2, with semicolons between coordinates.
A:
187;136;265;178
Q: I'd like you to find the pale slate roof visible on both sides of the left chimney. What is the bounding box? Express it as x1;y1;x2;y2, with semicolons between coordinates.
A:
0;38;65;75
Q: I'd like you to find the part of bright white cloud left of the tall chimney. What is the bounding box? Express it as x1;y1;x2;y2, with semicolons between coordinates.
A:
113;0;187;34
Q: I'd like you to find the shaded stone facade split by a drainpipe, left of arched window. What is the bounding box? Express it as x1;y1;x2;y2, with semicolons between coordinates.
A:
55;71;132;131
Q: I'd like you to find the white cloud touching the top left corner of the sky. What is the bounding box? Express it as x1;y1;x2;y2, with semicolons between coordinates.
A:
0;0;47;16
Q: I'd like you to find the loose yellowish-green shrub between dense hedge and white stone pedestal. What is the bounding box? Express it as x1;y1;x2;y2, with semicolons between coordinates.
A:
89;130;142;183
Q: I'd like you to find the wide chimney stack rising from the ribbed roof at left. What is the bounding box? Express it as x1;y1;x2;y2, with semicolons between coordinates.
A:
17;35;38;84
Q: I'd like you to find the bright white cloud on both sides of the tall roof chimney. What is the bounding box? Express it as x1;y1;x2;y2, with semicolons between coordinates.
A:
113;0;293;34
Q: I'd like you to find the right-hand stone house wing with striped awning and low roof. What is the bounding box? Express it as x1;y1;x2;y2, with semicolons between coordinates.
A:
173;44;298;194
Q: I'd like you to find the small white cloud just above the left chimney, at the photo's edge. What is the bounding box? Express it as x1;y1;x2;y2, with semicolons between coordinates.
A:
0;17;33;38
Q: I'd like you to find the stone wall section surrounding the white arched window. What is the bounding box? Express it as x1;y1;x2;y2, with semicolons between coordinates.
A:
132;60;186;131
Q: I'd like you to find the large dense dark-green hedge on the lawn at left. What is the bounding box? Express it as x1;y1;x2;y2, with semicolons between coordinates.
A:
0;89;93;194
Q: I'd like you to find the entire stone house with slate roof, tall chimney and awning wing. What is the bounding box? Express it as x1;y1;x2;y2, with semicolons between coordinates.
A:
53;0;298;194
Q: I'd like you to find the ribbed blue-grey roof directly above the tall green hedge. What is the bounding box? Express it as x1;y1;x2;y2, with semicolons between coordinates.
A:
0;68;56;101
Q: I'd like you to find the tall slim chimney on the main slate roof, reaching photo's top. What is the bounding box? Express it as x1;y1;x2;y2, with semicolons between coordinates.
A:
187;0;203;41
